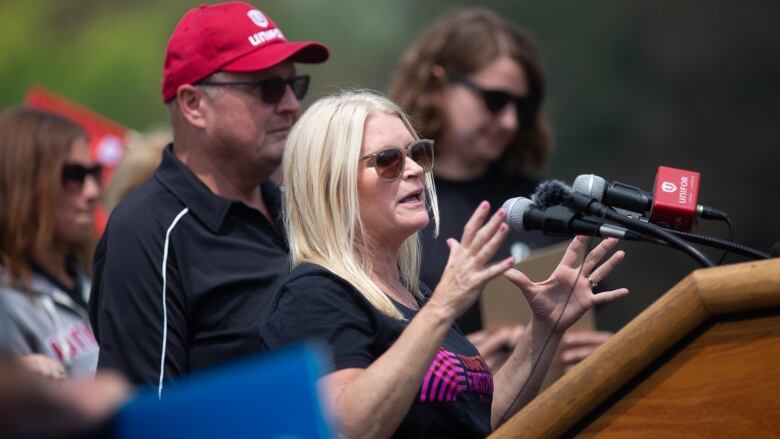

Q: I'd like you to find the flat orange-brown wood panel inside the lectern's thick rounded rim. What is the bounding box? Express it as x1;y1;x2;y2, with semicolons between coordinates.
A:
578;315;780;438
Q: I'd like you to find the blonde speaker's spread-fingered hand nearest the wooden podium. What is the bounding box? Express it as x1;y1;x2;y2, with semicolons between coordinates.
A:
505;236;628;333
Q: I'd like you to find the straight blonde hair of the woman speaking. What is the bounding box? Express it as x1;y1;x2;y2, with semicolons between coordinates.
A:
282;91;439;319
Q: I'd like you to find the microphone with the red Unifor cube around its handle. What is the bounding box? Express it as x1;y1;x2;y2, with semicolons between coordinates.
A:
573;166;728;232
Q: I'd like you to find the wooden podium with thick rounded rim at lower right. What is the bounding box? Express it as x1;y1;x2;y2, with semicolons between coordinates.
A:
490;259;780;438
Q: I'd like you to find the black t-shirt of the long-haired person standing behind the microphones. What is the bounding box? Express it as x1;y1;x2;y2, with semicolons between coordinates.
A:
420;169;561;334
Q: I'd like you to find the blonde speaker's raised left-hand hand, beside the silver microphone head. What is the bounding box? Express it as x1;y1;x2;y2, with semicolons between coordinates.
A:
431;201;512;319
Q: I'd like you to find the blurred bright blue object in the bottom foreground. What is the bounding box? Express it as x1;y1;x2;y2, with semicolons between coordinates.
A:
111;346;334;439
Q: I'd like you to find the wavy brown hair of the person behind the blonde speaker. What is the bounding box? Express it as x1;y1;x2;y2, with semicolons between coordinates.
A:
389;8;552;176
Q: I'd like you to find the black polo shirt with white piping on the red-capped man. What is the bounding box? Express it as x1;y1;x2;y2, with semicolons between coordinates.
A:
89;145;289;386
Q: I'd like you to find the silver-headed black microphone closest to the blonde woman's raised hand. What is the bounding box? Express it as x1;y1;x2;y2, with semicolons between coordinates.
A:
503;197;644;241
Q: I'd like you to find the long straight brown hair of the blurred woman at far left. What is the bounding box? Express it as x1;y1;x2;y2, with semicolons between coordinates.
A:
0;107;90;284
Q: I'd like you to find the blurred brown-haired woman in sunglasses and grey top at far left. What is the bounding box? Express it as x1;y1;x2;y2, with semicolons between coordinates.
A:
0;107;100;378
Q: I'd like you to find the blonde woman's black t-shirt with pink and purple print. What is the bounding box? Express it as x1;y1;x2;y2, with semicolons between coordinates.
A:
261;264;493;438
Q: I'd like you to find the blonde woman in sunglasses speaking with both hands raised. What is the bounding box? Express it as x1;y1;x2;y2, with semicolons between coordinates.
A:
260;92;628;438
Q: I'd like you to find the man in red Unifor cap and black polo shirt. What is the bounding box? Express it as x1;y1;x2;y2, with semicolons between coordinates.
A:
90;2;328;396
